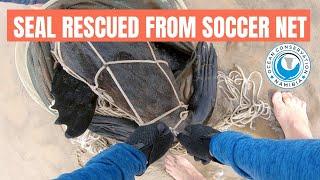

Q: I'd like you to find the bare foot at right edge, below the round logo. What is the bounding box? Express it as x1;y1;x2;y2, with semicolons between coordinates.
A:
272;92;312;139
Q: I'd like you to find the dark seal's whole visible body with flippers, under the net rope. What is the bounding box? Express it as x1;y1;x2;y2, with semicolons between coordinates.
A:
52;42;217;141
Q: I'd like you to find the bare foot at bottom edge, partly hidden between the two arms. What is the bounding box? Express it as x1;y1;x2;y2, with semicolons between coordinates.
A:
165;155;205;180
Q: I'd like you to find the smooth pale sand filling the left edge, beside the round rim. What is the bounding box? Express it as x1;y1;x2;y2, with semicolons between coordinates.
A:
0;3;77;179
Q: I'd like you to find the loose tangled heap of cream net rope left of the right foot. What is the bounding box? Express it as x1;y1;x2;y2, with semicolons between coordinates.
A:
215;65;272;131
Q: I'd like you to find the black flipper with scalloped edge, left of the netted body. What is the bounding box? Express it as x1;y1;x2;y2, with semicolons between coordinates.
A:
51;65;97;138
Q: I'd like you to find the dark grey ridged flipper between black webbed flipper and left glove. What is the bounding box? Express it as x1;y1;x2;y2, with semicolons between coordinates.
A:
89;115;139;142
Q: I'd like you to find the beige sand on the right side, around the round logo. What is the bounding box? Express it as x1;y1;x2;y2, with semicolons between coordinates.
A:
188;0;320;137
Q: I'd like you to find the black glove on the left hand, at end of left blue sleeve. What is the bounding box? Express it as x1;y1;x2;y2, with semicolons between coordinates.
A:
126;122;174;166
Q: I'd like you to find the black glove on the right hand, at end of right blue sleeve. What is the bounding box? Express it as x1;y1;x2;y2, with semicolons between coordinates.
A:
177;124;220;164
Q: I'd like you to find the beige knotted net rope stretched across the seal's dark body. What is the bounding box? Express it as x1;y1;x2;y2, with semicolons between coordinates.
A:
52;42;188;126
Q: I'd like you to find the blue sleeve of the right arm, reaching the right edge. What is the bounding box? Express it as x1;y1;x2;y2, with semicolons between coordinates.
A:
210;131;320;179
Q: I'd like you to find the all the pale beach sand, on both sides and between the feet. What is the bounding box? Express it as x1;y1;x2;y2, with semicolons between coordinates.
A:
0;0;320;179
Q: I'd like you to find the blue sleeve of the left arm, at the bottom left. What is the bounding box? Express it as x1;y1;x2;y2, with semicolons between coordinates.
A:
58;143;147;180
